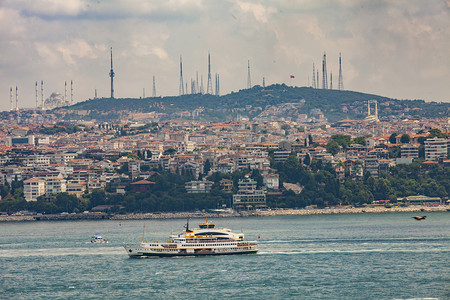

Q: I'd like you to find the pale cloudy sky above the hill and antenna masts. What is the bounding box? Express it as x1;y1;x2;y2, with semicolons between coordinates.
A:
0;0;450;111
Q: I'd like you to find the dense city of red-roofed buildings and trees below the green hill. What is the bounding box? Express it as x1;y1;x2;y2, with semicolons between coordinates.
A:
0;96;450;215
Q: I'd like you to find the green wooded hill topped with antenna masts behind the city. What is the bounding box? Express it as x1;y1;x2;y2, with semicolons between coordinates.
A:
55;84;450;122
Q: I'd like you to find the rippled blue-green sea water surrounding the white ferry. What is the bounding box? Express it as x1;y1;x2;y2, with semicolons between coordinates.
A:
0;212;450;299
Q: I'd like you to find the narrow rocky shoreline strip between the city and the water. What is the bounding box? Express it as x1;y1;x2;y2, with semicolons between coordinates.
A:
0;205;450;222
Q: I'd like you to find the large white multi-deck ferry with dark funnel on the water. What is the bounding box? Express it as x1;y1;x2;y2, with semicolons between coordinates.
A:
124;220;258;257
